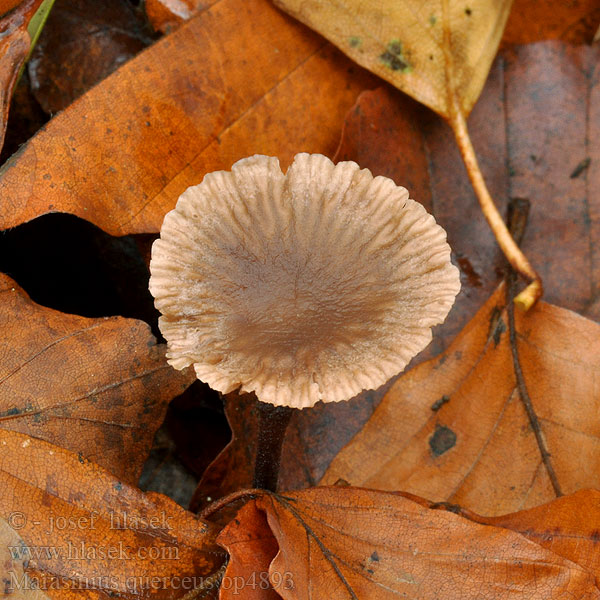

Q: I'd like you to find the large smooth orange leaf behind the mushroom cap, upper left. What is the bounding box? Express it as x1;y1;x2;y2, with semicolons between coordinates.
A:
0;0;373;235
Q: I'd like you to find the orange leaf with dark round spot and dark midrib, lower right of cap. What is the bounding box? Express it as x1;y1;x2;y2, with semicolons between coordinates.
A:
322;290;600;515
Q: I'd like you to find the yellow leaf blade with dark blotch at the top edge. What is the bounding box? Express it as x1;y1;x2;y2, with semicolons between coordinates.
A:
275;0;512;117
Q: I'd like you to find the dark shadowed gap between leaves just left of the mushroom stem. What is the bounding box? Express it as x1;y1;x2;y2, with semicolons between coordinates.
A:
139;381;231;507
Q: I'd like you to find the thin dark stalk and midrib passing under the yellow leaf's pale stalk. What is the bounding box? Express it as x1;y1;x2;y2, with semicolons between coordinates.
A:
506;198;563;497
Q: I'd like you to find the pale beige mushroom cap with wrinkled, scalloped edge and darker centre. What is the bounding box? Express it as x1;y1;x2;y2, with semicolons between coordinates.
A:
150;154;460;408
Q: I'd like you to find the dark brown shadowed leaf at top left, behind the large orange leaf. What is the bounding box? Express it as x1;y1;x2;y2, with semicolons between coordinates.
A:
28;0;152;114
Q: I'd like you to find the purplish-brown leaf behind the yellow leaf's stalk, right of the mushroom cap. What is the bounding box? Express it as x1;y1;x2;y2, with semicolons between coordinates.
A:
336;42;600;360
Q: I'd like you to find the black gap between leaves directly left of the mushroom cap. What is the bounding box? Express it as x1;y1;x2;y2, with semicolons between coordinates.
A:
0;213;162;339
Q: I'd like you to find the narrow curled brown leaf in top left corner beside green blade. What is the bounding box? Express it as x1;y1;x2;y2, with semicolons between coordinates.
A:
0;0;44;149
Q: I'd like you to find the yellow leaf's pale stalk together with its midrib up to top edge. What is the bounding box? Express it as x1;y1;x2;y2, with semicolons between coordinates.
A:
442;0;544;310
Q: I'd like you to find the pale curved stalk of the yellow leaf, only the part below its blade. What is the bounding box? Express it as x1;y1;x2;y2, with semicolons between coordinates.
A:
449;95;543;310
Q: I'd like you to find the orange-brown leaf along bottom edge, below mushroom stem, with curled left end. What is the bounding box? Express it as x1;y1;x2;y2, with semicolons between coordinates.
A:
217;487;600;600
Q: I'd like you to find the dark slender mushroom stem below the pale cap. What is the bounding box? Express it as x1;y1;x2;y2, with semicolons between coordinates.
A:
253;401;294;492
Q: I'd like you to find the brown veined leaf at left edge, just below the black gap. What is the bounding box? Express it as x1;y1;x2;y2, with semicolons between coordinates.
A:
0;274;195;482
